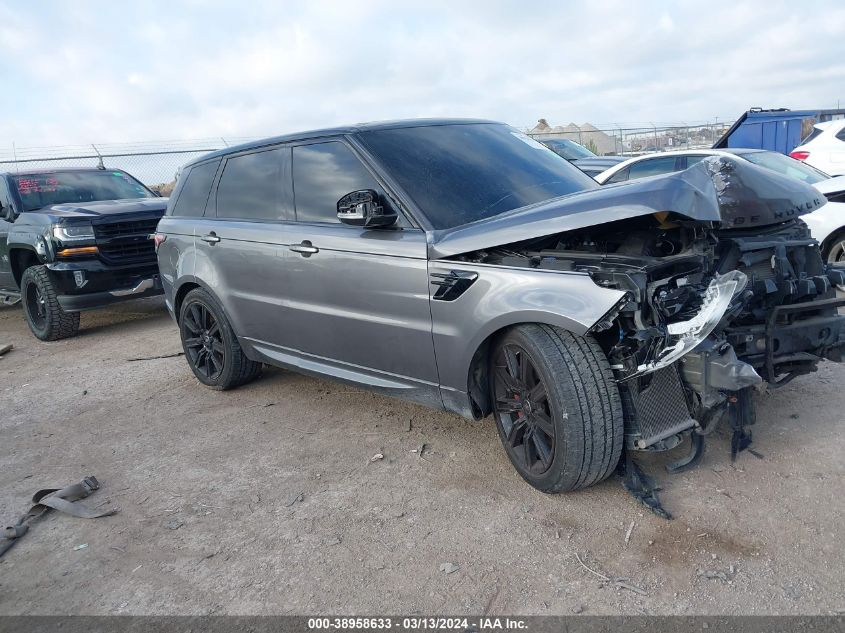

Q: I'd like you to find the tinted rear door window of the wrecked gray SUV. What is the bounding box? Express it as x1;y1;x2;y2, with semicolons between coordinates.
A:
217;147;292;220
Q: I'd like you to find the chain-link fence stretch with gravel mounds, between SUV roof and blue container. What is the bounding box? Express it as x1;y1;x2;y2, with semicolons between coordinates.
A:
527;119;728;156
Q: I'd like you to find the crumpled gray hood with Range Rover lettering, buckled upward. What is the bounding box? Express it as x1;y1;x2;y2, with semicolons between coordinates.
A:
429;156;825;259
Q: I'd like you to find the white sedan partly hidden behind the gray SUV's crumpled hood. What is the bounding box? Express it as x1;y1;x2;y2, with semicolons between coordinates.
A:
595;144;845;263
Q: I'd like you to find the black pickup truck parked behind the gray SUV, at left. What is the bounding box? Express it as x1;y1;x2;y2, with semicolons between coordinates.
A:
0;169;167;341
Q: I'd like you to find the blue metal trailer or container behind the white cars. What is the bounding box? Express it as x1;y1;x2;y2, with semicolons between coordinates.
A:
713;108;845;155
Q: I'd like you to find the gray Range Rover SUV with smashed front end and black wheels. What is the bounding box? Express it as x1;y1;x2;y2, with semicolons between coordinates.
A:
155;120;845;510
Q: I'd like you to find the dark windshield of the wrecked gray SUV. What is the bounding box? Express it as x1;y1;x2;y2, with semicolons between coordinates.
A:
358;123;599;229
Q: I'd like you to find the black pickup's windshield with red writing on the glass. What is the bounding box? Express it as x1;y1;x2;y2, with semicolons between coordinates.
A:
12;169;155;211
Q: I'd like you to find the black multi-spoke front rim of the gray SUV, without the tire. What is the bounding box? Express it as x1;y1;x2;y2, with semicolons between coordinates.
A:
493;343;556;475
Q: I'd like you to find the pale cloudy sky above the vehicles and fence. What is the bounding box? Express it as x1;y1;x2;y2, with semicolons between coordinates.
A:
0;0;845;150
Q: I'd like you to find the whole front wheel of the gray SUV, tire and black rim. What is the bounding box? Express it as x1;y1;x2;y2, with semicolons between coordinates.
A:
489;324;624;492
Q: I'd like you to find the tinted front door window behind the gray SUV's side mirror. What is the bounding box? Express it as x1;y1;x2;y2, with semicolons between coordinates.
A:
293;141;381;222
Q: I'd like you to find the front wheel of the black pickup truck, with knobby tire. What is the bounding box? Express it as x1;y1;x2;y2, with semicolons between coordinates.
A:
21;266;79;341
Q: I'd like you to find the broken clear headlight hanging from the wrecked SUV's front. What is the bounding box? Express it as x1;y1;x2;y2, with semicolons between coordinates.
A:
637;270;748;375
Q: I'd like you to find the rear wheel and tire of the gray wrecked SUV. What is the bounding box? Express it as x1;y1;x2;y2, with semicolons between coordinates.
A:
179;288;261;391
